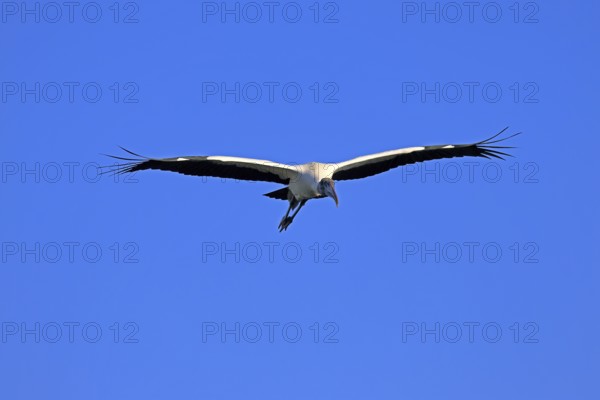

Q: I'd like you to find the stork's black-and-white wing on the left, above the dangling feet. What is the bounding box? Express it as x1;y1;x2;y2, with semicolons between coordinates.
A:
102;148;297;184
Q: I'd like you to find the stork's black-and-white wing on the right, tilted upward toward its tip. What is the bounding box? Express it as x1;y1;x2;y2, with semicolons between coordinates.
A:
332;128;520;181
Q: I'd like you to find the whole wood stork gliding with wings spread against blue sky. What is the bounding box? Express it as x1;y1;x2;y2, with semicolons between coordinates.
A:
102;128;520;232
